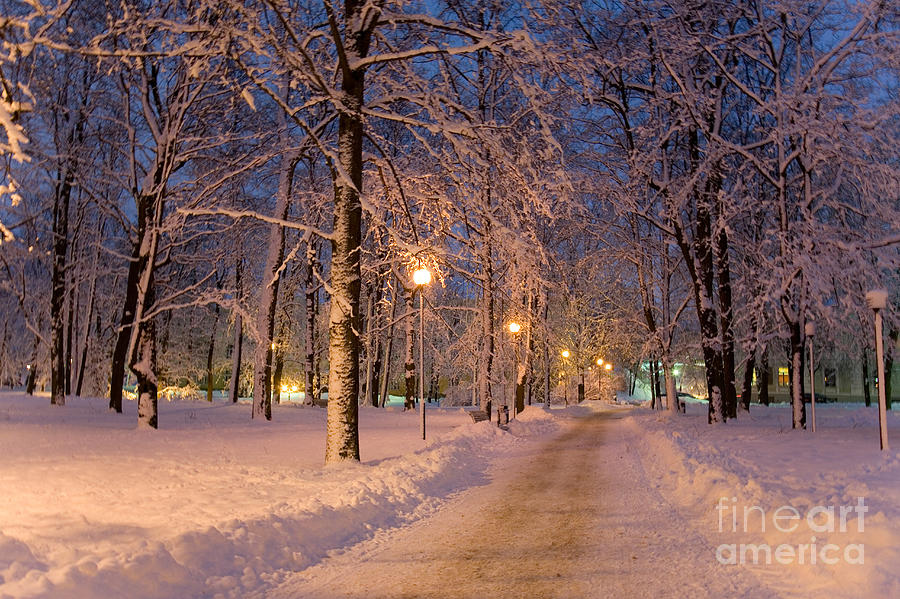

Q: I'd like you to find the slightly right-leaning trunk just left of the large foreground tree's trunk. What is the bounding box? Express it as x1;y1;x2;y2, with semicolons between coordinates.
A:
250;154;298;420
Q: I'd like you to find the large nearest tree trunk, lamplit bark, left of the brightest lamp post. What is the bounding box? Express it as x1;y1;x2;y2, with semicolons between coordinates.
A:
325;0;378;464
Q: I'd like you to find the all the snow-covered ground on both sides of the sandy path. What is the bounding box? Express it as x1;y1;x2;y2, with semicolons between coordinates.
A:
0;392;900;599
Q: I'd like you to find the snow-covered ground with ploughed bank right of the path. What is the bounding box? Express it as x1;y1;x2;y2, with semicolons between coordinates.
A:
629;404;900;598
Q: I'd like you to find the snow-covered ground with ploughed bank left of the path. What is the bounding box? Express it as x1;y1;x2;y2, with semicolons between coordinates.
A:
0;393;559;599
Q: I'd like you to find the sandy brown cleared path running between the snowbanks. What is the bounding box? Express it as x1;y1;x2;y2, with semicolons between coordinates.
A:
265;413;773;599
